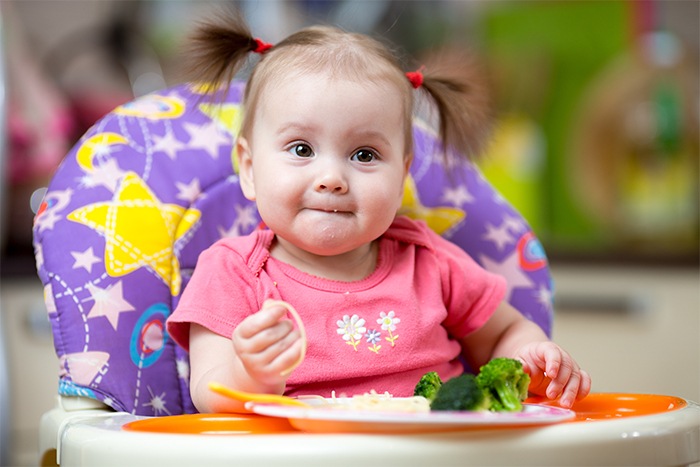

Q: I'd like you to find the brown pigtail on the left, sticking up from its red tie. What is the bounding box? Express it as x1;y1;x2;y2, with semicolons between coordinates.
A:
184;6;259;93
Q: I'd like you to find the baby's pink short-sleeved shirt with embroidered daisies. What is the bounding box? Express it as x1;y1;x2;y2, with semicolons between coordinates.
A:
167;217;506;397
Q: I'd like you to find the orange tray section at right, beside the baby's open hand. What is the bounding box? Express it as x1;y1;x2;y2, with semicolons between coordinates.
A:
527;393;687;422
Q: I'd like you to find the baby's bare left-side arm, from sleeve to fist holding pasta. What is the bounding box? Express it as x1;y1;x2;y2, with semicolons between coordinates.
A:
190;306;302;412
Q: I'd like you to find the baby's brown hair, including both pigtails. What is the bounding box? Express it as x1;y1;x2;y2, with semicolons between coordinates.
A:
186;7;491;157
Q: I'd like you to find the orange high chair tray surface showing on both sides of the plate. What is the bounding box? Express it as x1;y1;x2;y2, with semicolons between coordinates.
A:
123;393;687;435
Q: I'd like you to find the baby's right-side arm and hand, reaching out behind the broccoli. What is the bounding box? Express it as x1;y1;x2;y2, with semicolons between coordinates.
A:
462;303;591;407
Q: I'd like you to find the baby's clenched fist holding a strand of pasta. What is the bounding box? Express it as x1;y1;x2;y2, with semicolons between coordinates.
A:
231;302;304;385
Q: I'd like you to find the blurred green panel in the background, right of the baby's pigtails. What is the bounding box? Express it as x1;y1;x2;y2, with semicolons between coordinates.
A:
484;1;630;251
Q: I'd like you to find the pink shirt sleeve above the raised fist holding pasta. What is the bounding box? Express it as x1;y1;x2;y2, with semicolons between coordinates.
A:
167;241;259;351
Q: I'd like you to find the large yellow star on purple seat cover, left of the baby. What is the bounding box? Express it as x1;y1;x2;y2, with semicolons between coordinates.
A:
68;172;201;296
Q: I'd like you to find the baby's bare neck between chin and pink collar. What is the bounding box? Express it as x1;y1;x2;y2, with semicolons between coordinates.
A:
270;237;379;282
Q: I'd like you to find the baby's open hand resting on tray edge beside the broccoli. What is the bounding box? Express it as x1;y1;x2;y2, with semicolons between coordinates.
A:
514;341;591;408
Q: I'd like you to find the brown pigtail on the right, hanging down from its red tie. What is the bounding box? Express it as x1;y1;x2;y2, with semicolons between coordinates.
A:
420;47;493;159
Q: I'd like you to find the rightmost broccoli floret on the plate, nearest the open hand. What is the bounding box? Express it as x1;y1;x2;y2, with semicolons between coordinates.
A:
476;357;530;412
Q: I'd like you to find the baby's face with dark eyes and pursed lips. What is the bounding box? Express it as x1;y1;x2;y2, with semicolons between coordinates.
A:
239;74;409;256
